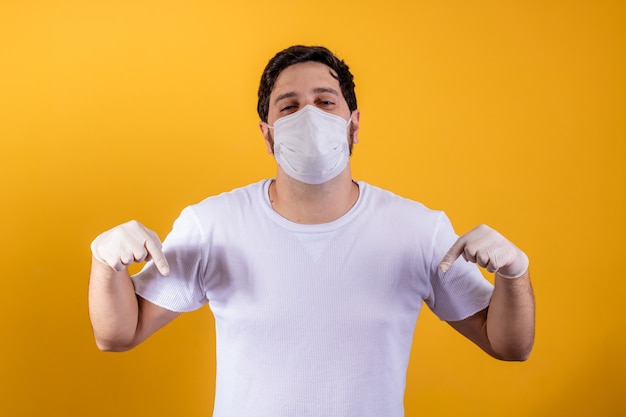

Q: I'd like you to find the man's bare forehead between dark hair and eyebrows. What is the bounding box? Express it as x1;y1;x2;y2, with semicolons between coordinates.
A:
271;61;339;96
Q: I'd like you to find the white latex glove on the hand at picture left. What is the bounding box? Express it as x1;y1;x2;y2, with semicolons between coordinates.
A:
91;220;170;276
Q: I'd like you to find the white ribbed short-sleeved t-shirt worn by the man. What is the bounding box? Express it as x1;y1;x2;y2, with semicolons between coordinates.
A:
133;180;493;417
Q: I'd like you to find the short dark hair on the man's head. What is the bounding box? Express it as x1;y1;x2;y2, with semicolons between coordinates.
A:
257;45;357;122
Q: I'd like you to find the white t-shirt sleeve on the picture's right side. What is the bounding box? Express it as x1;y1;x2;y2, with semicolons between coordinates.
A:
425;213;493;321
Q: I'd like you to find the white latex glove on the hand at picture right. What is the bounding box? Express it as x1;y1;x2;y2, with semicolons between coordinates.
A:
439;224;528;279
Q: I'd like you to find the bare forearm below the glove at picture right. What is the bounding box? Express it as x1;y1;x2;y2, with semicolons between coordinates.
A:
486;271;535;360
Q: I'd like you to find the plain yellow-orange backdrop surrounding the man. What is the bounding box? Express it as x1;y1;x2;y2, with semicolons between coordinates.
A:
0;0;626;417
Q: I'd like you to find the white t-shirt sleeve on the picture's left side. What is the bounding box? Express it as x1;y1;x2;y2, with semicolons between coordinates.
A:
132;207;207;312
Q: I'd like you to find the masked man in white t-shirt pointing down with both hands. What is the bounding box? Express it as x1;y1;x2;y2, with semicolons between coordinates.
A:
89;46;534;417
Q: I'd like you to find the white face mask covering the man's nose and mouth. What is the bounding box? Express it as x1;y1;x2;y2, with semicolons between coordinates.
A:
267;105;352;184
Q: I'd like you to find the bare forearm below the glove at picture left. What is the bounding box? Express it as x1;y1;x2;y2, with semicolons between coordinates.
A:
89;259;138;351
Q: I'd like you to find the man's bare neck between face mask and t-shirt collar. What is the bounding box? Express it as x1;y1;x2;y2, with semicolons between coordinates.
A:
269;169;359;224
